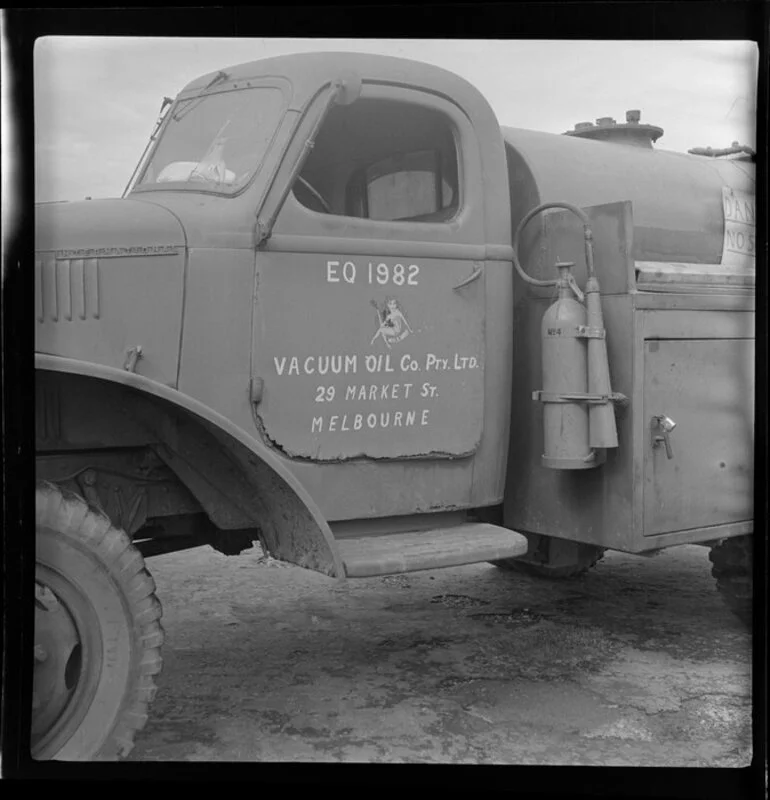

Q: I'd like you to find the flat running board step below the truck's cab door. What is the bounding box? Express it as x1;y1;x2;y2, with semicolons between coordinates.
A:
337;523;527;578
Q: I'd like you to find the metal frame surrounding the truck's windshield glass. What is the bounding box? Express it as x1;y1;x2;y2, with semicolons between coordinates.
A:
126;77;291;198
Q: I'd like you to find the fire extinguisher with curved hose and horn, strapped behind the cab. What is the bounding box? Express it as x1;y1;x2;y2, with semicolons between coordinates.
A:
513;203;626;469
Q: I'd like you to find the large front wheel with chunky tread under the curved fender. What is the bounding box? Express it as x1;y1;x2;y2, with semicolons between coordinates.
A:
31;482;163;761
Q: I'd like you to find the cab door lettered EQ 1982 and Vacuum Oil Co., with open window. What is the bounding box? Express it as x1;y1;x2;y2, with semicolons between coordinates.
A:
252;82;485;461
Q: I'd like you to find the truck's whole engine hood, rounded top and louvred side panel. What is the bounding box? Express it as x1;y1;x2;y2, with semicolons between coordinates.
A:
34;194;185;386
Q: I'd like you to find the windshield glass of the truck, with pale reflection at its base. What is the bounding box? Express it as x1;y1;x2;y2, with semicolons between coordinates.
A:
134;87;284;194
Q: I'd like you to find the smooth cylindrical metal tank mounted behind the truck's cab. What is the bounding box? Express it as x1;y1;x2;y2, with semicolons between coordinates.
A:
502;123;754;264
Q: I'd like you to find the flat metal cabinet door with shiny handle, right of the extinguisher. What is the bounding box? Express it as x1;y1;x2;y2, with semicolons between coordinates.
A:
644;339;754;536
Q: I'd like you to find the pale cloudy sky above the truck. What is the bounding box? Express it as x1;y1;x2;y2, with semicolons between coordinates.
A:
34;37;758;201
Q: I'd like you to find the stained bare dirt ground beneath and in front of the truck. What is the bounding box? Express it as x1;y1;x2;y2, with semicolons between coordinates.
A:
128;546;751;767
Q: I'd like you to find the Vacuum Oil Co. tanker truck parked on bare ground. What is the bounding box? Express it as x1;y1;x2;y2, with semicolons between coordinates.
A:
30;53;756;760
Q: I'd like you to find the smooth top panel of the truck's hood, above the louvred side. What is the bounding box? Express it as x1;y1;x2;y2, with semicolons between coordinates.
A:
35;199;185;257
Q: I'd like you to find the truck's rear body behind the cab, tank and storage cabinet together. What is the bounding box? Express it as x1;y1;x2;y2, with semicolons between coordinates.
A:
496;117;756;576
